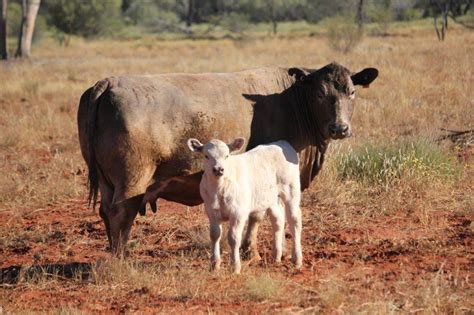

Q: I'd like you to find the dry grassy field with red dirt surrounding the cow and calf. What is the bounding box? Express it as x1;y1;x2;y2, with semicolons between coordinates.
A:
0;26;474;314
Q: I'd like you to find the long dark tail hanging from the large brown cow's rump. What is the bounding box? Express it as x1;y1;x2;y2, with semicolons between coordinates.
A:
86;79;110;209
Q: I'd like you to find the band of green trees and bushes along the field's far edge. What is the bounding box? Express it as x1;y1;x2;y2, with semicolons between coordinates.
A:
15;0;467;40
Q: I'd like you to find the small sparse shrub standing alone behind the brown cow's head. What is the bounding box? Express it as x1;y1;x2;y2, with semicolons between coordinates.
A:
323;16;364;53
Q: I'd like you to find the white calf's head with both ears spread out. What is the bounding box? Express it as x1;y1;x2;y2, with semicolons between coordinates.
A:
187;138;245;177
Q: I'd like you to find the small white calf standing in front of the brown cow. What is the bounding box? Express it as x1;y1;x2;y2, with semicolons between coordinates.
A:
188;138;303;273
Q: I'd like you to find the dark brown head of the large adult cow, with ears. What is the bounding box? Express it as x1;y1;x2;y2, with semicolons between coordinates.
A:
290;63;378;139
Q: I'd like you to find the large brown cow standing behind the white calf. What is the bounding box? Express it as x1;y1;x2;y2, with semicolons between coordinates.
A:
78;63;378;255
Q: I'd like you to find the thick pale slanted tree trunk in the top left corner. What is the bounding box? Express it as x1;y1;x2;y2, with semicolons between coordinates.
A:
15;0;41;58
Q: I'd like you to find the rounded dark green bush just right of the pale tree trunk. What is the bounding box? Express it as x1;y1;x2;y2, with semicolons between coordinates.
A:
45;0;121;37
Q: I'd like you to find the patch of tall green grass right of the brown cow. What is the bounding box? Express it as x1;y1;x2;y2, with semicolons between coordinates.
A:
336;140;460;185
